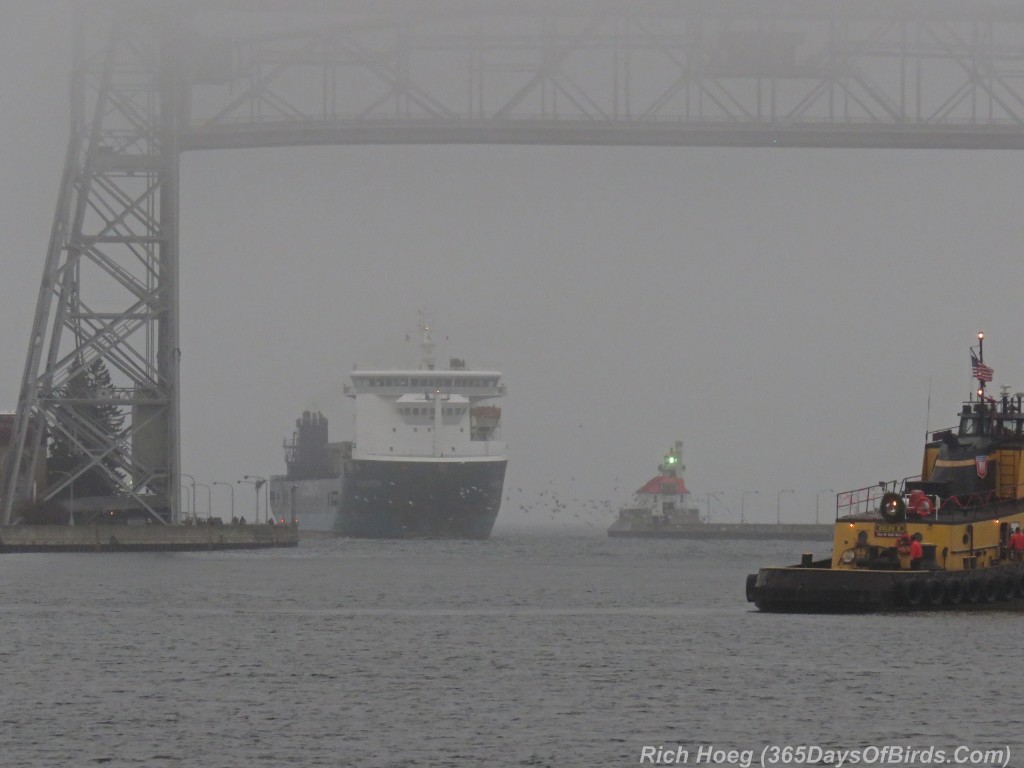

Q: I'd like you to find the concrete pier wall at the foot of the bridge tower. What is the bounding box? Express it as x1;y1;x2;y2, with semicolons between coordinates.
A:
0;524;299;553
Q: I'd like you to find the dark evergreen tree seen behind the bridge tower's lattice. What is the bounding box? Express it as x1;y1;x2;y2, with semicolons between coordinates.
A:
47;357;124;499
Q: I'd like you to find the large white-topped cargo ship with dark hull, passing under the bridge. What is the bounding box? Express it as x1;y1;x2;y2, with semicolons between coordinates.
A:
270;323;508;539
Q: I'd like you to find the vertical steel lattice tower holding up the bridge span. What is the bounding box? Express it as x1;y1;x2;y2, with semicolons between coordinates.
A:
2;6;178;523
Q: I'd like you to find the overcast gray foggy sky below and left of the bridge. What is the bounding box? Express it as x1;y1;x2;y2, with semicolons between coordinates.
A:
0;0;1024;525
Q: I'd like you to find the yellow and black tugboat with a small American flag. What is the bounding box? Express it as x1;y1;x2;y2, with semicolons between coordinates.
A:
746;333;1024;613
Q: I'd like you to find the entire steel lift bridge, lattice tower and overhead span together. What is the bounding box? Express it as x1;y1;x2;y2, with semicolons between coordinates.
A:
6;0;1024;523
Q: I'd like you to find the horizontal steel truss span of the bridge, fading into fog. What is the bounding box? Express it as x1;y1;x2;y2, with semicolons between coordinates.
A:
181;0;1024;148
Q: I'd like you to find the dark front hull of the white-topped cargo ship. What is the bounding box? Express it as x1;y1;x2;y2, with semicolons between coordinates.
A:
338;458;508;539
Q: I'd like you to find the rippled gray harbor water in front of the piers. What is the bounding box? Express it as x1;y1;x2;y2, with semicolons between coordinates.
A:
0;526;1024;768
